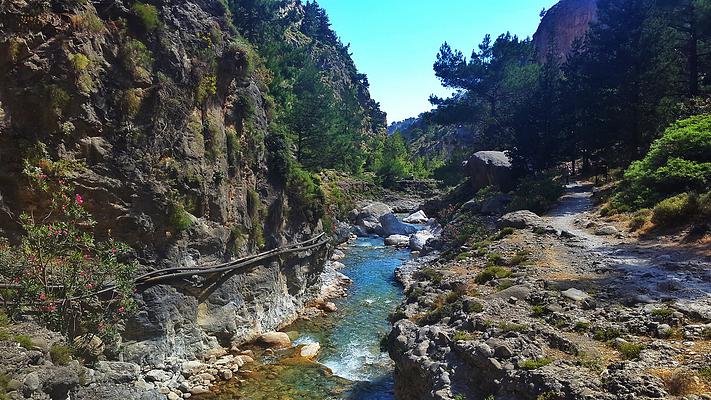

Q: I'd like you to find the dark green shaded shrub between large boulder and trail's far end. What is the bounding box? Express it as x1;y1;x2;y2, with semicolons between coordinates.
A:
509;175;563;213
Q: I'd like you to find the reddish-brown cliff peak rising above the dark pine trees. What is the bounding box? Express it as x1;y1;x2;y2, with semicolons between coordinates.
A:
533;0;597;63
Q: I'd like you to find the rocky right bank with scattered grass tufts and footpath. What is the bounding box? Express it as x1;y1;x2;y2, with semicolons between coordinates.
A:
388;187;711;400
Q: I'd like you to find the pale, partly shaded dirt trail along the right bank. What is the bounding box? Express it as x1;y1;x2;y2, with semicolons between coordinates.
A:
545;183;711;320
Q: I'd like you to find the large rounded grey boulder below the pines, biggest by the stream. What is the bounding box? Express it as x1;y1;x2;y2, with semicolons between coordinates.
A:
464;151;513;191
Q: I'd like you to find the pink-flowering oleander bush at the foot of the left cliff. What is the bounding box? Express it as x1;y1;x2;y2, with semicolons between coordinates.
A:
0;145;136;340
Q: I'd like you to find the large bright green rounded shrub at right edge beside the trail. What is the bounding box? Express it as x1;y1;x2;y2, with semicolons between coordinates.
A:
612;115;711;211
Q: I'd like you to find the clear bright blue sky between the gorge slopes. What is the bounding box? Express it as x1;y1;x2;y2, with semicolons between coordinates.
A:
318;0;557;123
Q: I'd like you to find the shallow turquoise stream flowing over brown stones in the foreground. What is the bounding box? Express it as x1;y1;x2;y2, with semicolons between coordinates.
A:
211;238;410;400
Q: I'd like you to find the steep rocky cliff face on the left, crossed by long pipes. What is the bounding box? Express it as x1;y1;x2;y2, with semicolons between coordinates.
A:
0;0;377;363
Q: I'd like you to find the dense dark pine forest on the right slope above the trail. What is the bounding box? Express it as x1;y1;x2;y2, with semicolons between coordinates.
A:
392;0;711;219
